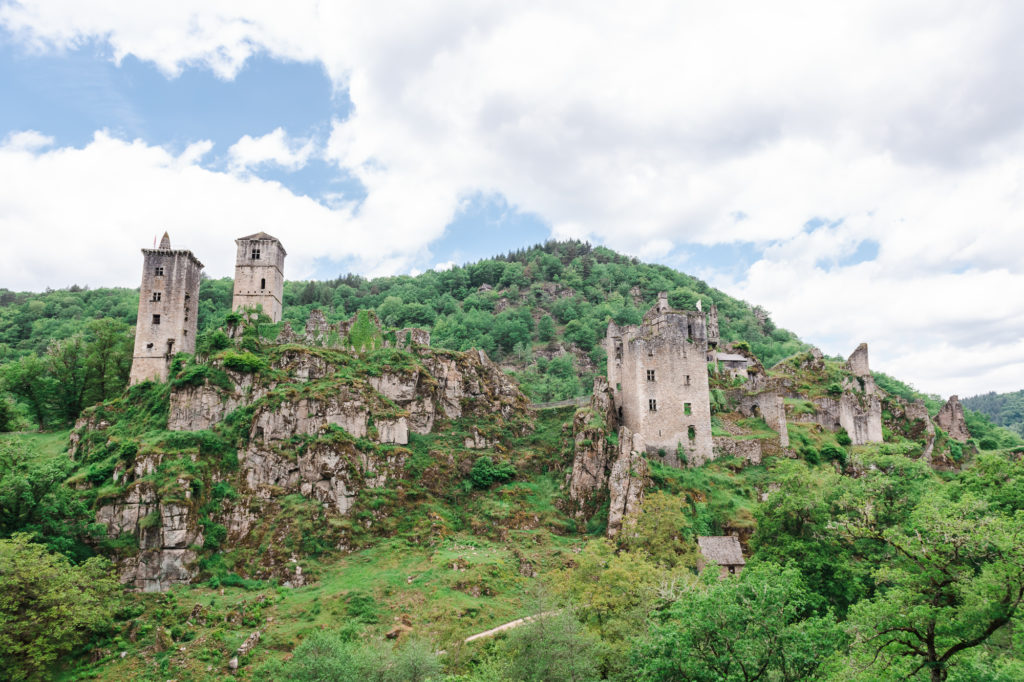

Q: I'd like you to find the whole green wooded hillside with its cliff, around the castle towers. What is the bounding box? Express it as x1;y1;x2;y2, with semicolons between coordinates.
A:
0;243;1024;682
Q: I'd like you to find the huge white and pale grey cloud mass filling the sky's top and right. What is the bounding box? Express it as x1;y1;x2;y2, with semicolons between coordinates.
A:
0;0;1024;393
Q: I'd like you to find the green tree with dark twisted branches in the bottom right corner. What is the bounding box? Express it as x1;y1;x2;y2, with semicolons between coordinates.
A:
846;489;1024;682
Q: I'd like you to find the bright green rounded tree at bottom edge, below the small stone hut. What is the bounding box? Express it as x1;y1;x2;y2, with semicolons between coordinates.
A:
633;563;843;682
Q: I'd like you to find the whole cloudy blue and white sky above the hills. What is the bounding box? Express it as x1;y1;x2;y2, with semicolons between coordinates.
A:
0;0;1024;396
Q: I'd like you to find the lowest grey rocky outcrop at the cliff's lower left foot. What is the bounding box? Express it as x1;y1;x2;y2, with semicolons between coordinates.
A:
96;480;203;592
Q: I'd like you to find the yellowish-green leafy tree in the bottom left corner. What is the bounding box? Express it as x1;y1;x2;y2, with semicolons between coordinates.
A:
0;535;120;680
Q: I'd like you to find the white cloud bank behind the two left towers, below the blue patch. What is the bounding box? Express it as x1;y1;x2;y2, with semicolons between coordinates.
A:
0;132;364;290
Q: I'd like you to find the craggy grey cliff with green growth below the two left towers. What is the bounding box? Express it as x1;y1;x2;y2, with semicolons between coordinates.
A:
73;333;529;591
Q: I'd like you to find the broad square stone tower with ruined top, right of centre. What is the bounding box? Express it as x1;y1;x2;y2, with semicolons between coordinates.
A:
605;293;718;466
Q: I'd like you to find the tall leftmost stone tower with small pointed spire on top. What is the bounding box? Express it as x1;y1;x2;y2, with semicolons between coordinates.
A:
130;232;203;384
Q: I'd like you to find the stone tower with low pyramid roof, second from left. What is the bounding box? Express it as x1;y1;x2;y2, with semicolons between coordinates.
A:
231;232;288;322
